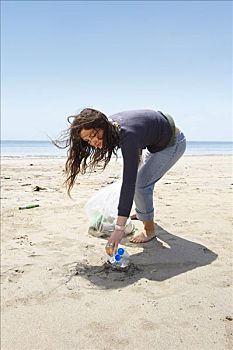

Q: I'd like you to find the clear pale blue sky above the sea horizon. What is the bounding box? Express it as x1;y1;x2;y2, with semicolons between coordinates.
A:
1;1;232;141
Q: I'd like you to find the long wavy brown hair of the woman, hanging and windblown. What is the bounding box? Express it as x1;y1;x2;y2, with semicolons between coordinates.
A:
53;108;119;196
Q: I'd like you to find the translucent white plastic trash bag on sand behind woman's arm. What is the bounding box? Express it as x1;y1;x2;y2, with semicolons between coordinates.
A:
85;181;134;237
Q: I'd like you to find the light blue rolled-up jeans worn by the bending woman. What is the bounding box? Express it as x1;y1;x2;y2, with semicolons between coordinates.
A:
134;131;186;221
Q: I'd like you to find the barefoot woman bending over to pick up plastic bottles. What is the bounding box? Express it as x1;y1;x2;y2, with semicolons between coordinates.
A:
57;108;186;251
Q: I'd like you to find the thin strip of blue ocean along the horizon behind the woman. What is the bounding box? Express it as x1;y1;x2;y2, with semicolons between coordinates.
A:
1;140;233;157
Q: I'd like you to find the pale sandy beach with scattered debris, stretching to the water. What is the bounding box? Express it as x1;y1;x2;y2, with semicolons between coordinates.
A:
1;155;233;350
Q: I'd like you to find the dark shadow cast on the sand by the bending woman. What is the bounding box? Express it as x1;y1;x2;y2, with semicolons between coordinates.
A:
66;225;218;289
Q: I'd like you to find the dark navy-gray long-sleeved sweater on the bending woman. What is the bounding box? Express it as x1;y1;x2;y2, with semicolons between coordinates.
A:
110;110;172;217
